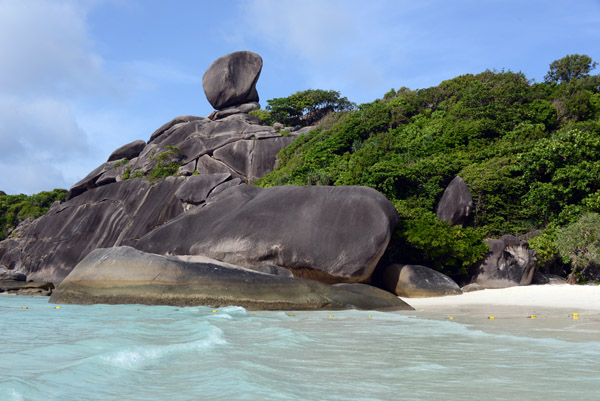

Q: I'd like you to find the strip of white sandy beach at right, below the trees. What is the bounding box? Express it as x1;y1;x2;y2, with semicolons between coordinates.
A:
402;284;600;313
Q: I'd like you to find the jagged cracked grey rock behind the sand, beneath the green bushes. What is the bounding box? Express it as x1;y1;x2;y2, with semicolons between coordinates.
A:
473;235;537;288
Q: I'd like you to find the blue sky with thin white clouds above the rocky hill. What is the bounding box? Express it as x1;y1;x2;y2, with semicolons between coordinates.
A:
0;0;600;194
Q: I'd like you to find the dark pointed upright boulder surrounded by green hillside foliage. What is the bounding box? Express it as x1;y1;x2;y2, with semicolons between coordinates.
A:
436;176;473;226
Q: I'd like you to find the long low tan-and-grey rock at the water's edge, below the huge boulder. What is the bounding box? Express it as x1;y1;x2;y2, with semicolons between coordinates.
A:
50;247;412;310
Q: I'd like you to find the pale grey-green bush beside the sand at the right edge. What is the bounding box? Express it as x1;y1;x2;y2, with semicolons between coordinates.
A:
556;213;600;284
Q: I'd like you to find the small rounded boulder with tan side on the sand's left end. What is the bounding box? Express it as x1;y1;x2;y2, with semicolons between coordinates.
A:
382;264;462;298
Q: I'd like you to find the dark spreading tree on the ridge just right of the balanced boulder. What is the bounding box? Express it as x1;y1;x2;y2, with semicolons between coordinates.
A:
266;89;356;126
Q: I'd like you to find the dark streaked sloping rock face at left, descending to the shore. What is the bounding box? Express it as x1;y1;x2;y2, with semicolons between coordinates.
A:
0;177;192;283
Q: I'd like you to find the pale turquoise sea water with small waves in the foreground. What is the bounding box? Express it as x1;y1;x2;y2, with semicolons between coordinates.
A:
0;296;600;401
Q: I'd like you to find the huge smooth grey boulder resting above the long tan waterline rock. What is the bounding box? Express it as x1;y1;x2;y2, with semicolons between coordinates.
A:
136;185;397;283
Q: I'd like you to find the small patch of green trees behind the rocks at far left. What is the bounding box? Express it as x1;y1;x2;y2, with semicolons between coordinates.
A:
0;189;67;240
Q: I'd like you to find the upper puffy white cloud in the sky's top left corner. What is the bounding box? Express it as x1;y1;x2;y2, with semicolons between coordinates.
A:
0;0;105;95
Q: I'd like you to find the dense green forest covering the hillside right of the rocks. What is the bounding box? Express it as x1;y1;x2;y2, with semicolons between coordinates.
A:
258;54;600;278
